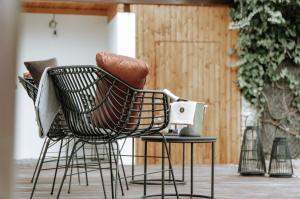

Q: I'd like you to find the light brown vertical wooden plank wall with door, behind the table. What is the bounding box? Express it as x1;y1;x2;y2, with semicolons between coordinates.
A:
131;5;241;163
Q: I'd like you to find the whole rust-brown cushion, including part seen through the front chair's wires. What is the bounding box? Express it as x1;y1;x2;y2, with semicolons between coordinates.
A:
93;52;149;129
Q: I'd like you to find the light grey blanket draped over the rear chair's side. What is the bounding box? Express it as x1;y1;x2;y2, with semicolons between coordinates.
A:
34;67;61;137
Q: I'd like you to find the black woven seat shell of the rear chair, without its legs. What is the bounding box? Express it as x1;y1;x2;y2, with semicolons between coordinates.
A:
18;77;70;140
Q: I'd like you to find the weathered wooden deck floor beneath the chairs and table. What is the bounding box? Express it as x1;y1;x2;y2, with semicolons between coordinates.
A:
14;162;300;199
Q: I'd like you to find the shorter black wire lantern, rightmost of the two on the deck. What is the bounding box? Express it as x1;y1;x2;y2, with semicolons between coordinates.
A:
269;137;293;177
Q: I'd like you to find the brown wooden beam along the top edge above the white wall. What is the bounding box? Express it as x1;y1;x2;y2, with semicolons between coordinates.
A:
22;0;233;16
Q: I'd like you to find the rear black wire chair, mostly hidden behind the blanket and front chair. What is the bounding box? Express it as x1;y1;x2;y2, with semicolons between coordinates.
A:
18;77;128;198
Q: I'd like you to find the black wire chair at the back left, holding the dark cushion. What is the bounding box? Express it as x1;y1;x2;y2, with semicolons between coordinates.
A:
18;77;129;198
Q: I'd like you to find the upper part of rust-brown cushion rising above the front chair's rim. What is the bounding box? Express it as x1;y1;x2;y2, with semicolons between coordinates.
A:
96;52;149;88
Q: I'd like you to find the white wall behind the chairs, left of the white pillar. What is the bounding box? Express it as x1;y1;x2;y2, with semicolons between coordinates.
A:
12;13;108;159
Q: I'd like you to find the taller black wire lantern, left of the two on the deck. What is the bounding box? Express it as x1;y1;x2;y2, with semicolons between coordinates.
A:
238;126;266;175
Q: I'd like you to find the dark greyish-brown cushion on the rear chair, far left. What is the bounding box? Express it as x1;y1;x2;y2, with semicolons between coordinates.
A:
24;58;57;84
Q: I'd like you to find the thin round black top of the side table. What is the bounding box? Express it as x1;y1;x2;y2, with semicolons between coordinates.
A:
141;135;217;143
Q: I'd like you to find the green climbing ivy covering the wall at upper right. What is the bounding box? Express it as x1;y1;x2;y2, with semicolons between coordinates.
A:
229;0;300;113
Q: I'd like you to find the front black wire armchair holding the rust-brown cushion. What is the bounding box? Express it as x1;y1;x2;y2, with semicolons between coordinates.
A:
48;66;178;199
